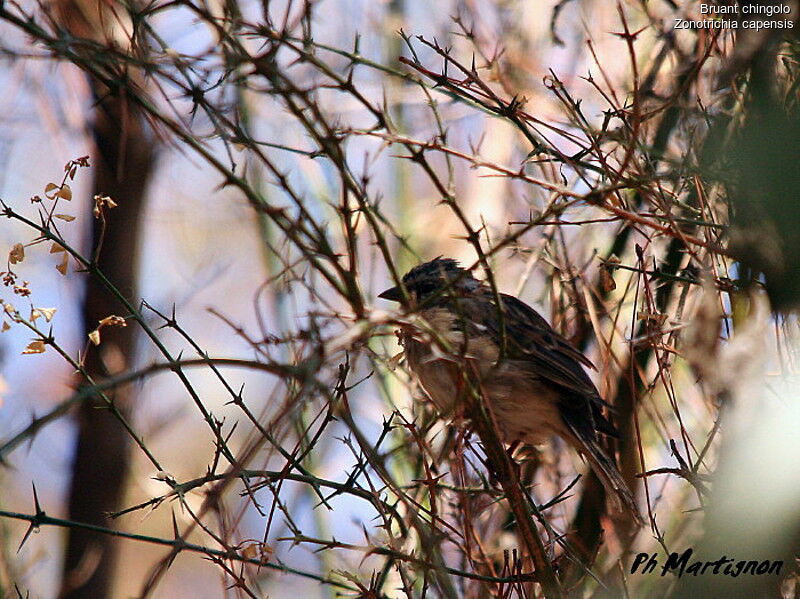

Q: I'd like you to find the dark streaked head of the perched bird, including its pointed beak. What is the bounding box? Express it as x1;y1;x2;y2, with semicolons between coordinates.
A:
378;257;481;302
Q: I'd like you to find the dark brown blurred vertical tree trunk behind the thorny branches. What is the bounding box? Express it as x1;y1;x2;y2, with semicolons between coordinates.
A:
58;0;153;599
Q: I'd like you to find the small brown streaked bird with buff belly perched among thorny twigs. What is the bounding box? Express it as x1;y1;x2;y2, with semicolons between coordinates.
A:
378;256;642;523
